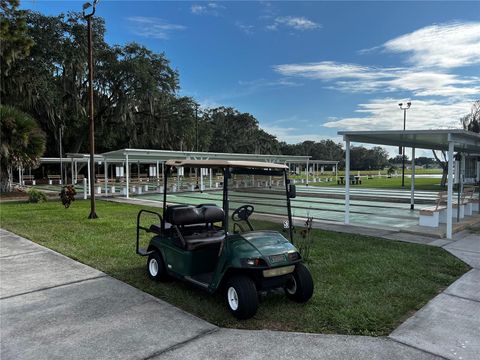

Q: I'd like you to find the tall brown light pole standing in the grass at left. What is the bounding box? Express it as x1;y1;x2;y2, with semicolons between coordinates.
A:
83;0;99;219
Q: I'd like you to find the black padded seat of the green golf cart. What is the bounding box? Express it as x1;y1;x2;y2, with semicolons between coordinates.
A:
165;204;225;250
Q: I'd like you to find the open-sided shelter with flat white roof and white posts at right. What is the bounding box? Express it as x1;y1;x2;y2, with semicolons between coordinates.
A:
338;129;480;239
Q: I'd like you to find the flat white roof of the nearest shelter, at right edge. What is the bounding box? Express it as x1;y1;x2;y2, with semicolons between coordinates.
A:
338;129;480;153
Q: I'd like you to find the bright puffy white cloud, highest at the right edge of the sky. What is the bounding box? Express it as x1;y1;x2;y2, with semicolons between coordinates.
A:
383;22;480;68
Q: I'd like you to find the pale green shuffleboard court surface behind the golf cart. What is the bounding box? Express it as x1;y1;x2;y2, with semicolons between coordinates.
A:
131;186;437;228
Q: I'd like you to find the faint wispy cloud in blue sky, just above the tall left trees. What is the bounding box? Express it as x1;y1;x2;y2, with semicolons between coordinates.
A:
127;16;186;39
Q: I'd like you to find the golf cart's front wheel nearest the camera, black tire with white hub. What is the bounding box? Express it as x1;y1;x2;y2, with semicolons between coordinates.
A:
225;276;258;320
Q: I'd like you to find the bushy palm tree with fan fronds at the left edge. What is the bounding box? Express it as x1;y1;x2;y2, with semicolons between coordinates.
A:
0;105;45;192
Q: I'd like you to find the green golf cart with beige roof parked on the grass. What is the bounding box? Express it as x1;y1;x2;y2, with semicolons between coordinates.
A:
136;160;313;319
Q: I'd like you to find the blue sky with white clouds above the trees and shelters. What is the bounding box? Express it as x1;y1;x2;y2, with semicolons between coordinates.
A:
22;0;480;152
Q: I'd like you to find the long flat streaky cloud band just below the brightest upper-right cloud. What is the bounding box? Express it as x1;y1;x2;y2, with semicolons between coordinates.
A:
273;61;480;96
